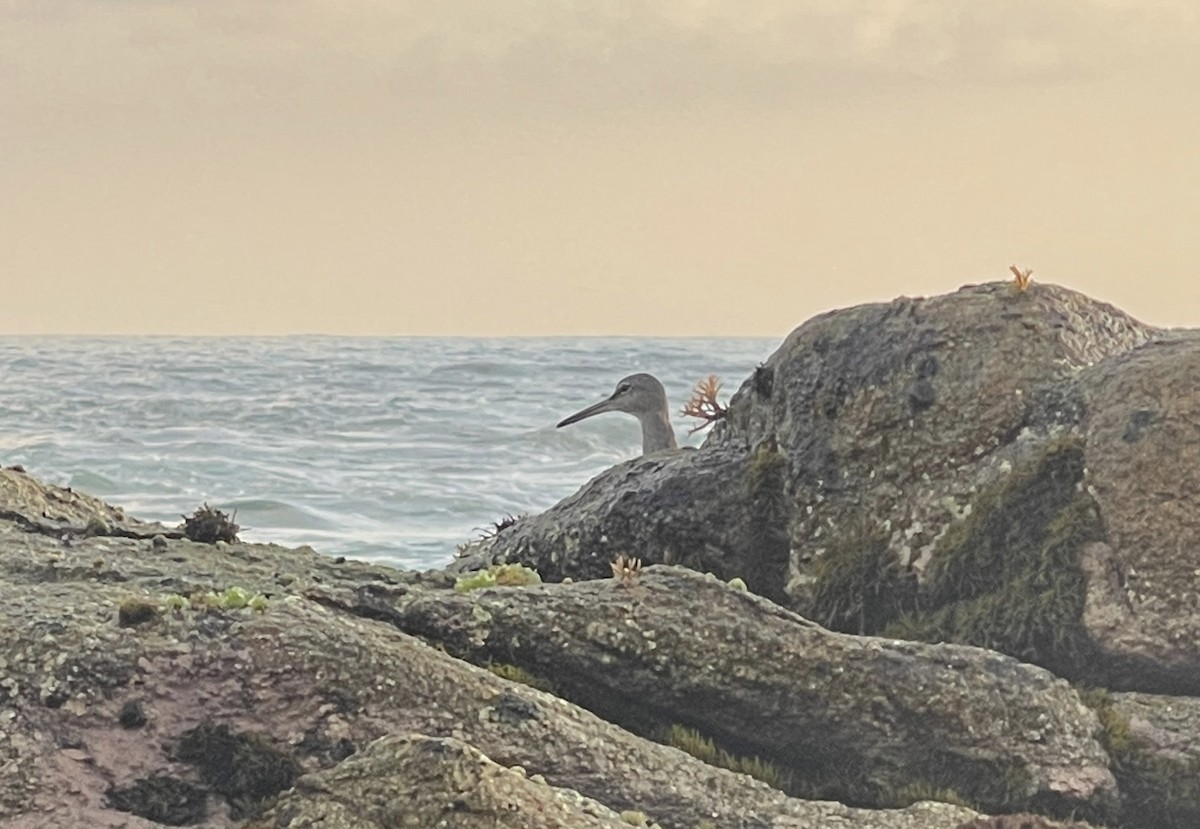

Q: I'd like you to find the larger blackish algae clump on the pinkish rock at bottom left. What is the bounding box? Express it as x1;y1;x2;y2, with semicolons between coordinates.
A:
175;722;300;819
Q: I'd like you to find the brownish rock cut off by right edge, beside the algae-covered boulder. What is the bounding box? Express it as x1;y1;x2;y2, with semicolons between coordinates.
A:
1080;336;1200;693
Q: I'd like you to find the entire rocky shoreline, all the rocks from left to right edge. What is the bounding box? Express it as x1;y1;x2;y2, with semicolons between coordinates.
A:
0;284;1200;829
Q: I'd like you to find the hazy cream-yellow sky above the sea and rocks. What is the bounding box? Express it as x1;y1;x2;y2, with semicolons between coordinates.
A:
0;0;1200;336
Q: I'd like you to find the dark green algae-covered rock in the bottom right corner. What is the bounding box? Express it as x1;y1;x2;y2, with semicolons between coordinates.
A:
1079;689;1200;829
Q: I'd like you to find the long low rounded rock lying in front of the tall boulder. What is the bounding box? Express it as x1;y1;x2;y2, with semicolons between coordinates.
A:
322;566;1116;816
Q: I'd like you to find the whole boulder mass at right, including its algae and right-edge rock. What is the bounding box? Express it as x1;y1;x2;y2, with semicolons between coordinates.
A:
457;284;1200;693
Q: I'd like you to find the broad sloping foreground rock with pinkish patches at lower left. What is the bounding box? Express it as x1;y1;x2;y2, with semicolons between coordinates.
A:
0;521;993;829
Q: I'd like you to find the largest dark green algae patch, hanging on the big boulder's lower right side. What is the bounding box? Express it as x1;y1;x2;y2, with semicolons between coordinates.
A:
881;437;1104;679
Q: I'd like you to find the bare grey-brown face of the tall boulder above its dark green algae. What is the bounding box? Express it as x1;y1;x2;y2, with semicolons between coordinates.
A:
463;284;1157;590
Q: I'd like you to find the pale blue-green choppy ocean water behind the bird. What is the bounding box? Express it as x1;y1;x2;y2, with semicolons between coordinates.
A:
0;337;780;567
